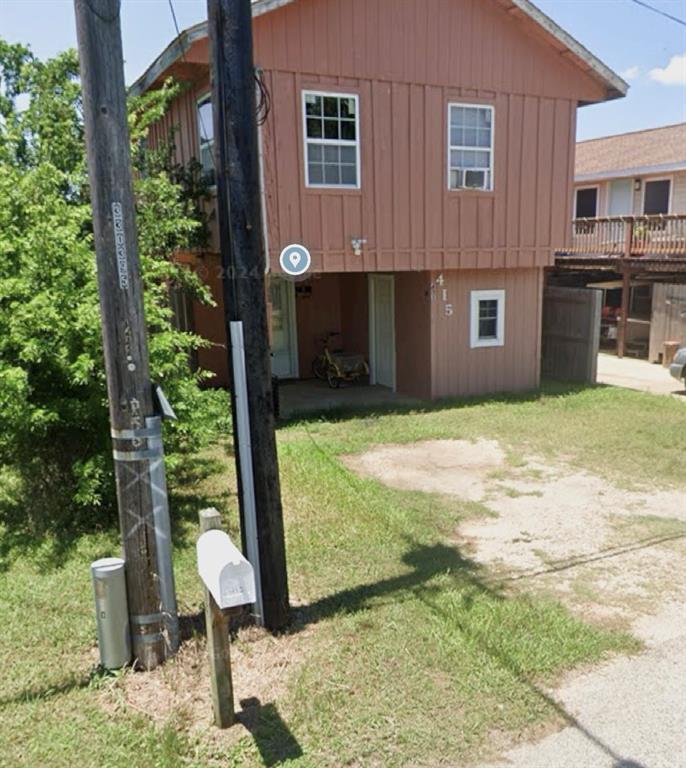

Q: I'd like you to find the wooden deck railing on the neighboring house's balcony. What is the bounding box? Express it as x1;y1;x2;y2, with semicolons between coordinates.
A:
557;214;686;259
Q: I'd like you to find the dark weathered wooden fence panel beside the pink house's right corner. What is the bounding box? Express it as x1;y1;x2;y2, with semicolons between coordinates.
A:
541;286;602;384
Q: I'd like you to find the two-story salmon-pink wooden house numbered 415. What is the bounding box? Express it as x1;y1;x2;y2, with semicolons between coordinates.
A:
133;0;627;398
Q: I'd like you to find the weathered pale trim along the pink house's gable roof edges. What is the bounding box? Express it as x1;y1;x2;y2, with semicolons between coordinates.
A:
130;0;629;100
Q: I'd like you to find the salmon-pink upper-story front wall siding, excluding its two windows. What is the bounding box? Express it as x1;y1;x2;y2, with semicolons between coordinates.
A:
255;0;602;272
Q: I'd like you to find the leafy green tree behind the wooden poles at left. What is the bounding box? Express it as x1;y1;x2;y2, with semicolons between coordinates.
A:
0;40;231;535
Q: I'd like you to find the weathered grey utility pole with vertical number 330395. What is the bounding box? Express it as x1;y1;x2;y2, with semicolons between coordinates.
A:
75;0;176;669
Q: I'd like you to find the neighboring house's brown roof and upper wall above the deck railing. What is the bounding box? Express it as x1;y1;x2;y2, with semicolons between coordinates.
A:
574;123;686;218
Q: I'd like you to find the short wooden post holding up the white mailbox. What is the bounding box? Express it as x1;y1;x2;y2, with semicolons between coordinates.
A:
199;509;236;728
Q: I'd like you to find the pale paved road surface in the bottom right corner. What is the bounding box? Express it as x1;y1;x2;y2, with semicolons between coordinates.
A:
489;606;686;768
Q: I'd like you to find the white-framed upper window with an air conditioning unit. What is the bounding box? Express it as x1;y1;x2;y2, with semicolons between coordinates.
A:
448;104;493;190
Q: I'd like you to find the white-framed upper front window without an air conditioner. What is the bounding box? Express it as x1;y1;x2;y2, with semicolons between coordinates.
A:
303;91;360;189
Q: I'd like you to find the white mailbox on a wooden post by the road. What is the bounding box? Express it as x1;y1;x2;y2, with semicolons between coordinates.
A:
197;530;255;608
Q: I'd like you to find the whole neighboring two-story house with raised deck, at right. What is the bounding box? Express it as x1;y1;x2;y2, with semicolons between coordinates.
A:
553;123;686;362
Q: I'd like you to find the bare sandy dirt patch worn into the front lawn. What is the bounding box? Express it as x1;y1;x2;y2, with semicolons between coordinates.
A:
344;440;686;642
